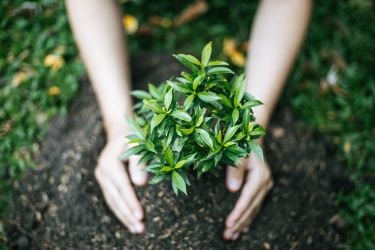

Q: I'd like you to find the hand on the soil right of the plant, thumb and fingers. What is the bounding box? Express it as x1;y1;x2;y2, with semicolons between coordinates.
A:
223;150;273;240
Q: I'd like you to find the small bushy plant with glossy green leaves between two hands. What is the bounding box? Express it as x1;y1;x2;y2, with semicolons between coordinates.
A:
123;43;265;194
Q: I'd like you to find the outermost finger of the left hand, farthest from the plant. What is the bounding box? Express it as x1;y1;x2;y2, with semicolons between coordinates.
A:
98;171;144;233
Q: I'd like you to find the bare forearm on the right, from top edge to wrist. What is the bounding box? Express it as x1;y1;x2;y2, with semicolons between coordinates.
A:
247;0;312;126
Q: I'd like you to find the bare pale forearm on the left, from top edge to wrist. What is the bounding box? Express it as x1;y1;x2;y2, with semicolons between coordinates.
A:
66;0;132;137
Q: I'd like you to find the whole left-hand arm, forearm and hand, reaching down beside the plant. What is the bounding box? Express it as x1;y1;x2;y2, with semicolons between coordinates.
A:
66;0;146;233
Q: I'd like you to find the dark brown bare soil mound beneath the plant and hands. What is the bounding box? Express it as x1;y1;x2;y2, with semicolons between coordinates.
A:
5;55;350;250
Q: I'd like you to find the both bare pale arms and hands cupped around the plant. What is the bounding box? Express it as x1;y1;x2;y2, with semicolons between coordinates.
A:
66;0;312;240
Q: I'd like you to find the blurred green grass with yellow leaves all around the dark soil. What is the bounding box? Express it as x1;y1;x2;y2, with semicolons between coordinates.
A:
0;0;375;249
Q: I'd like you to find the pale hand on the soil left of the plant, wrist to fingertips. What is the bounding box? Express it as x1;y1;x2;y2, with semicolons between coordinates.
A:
95;129;147;233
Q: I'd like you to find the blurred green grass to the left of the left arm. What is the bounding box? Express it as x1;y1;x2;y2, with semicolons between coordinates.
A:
0;0;83;213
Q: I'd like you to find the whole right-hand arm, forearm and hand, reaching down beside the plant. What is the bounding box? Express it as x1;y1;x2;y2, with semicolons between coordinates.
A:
224;0;312;240
